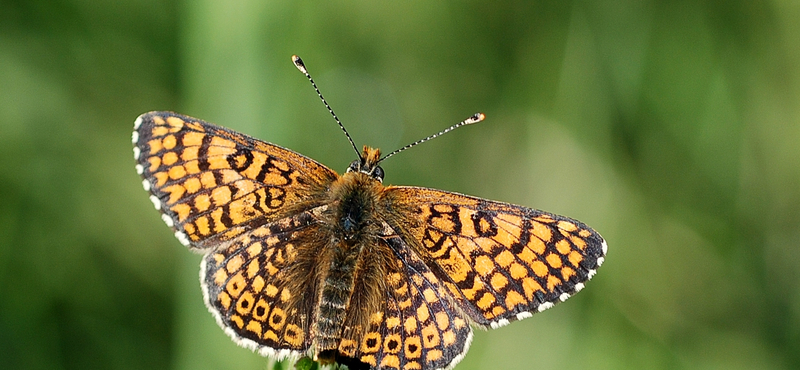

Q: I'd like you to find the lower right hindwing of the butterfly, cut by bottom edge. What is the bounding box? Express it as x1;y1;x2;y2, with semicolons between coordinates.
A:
339;225;472;369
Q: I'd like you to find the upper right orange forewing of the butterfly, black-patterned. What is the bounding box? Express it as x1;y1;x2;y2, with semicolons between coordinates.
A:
386;187;607;328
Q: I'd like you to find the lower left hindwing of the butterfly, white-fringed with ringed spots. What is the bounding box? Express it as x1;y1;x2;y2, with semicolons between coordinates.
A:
200;206;327;359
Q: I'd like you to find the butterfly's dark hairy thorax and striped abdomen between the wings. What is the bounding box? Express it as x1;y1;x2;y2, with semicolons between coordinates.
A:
313;162;391;357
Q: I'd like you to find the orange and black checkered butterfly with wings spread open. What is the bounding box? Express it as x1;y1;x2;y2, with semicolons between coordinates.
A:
133;57;606;370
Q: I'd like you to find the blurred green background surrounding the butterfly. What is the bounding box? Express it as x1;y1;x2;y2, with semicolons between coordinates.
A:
0;0;800;370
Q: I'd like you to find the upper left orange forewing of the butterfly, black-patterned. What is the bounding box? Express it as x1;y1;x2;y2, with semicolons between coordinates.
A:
132;112;338;249
